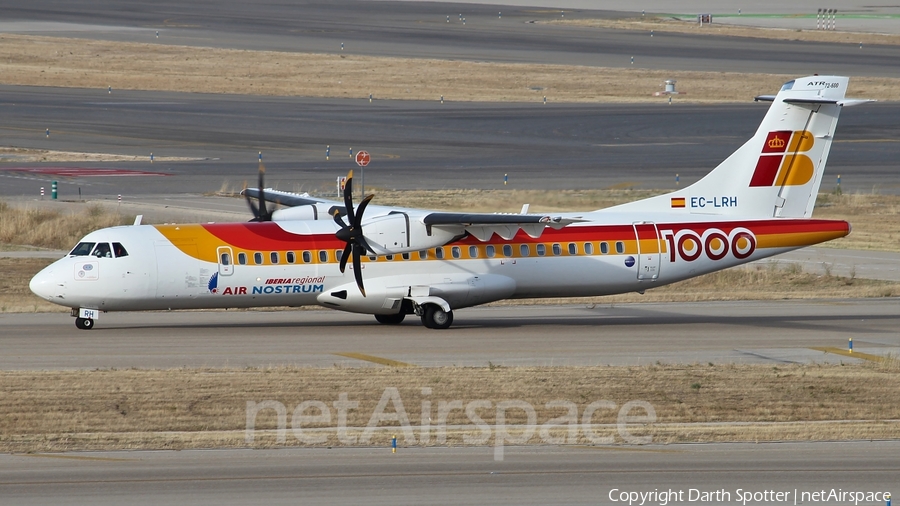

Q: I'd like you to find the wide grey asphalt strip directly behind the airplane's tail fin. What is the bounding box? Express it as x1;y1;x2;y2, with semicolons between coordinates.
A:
0;87;900;199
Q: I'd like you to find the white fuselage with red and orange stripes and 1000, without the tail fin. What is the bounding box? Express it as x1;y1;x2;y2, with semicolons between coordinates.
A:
31;213;849;314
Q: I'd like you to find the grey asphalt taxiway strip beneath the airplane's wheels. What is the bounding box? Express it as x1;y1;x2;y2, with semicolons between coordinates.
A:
0;299;900;370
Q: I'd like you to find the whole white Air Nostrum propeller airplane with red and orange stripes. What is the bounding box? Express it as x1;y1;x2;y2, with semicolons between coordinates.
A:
30;75;870;330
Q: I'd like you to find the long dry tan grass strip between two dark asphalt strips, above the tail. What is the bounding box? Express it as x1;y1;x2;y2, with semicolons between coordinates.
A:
0;34;900;102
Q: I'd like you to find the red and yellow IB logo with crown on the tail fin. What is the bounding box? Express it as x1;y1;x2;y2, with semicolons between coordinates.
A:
750;130;815;186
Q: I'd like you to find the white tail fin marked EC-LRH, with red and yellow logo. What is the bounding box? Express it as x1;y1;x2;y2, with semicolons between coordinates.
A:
616;76;868;218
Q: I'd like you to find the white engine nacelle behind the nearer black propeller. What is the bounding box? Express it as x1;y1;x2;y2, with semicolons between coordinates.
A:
363;212;457;255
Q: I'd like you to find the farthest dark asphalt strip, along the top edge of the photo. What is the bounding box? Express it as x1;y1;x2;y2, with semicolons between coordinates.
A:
0;0;900;77
